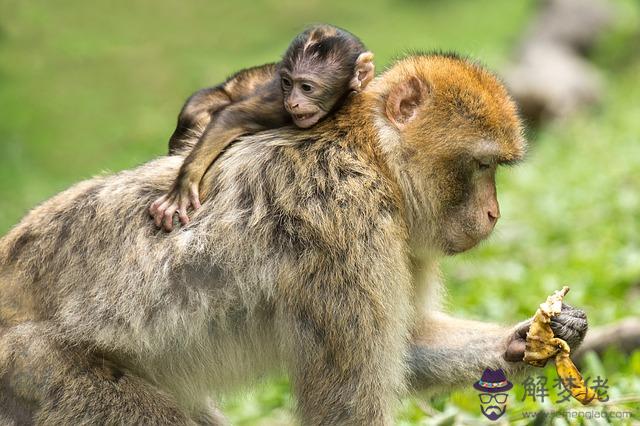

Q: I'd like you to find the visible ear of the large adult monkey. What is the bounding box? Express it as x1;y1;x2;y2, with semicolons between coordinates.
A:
385;77;429;130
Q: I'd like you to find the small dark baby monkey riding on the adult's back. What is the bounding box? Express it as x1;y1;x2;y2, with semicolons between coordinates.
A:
149;25;374;231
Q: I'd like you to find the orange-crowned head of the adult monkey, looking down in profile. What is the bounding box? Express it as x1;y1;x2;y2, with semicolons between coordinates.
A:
369;54;526;254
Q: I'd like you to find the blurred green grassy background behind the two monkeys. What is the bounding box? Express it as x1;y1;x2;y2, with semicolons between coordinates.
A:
0;0;640;425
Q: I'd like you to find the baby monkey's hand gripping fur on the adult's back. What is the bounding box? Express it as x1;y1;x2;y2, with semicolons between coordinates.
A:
149;179;200;232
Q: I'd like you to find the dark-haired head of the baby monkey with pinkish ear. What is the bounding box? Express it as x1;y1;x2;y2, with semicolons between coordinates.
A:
279;25;374;128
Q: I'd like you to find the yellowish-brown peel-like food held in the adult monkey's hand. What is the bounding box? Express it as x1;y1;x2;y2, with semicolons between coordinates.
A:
524;286;596;405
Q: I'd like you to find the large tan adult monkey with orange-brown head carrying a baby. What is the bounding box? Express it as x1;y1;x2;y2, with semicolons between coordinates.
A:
0;54;586;425
